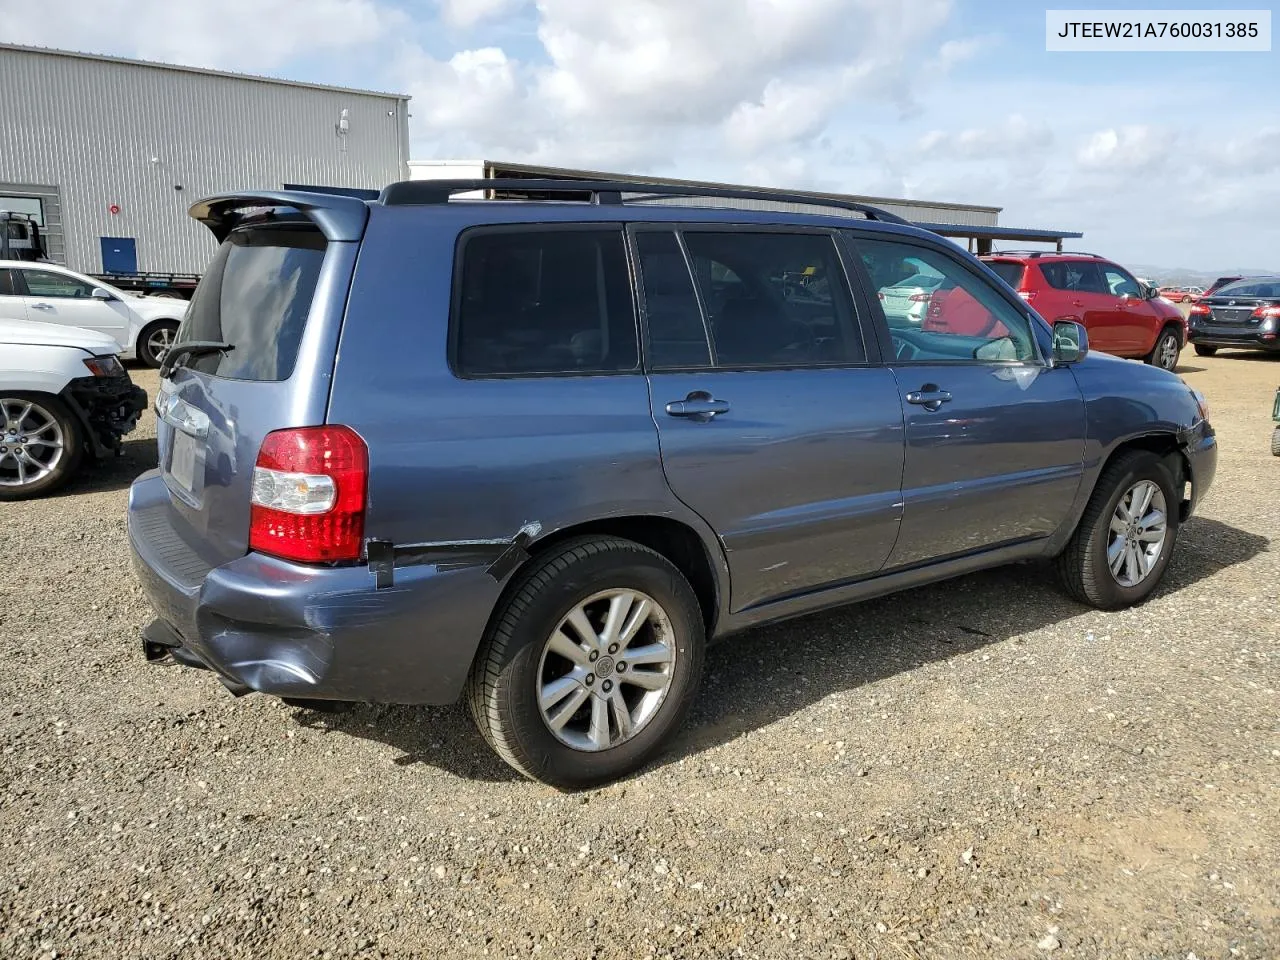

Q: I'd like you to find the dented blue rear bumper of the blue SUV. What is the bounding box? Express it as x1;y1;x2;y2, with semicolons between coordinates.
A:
128;471;502;704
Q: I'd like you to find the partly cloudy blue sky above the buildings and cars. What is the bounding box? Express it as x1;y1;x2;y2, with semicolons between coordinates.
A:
0;0;1280;271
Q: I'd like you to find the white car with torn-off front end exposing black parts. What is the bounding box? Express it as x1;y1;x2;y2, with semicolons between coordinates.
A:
0;319;147;500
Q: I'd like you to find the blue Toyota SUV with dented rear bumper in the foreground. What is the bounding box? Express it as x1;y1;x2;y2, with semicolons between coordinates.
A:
128;179;1217;787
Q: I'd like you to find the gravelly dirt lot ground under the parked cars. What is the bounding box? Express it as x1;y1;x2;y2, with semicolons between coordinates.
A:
0;351;1280;960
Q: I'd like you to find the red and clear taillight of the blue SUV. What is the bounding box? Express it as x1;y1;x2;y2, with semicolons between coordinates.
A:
248;426;369;563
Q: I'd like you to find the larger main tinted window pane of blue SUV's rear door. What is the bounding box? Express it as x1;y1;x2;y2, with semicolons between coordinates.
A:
684;232;867;366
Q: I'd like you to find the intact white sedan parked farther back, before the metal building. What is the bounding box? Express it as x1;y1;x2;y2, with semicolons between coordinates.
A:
0;260;187;367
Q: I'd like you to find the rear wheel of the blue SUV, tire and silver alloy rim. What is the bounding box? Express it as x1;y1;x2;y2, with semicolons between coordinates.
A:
467;538;705;790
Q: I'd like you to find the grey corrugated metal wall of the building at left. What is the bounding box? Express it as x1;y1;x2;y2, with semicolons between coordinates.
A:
0;47;408;273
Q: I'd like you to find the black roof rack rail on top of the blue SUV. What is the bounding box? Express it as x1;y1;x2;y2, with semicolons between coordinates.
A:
379;178;910;225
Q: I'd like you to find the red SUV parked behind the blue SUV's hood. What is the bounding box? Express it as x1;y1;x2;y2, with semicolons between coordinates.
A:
983;251;1187;370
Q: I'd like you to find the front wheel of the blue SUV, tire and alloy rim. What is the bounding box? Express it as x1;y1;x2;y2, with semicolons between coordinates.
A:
1057;451;1181;611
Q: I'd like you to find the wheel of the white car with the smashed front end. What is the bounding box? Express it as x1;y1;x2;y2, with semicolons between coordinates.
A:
0;390;84;500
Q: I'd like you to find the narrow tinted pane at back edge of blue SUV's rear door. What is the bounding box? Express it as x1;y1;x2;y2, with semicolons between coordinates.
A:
636;230;712;370
